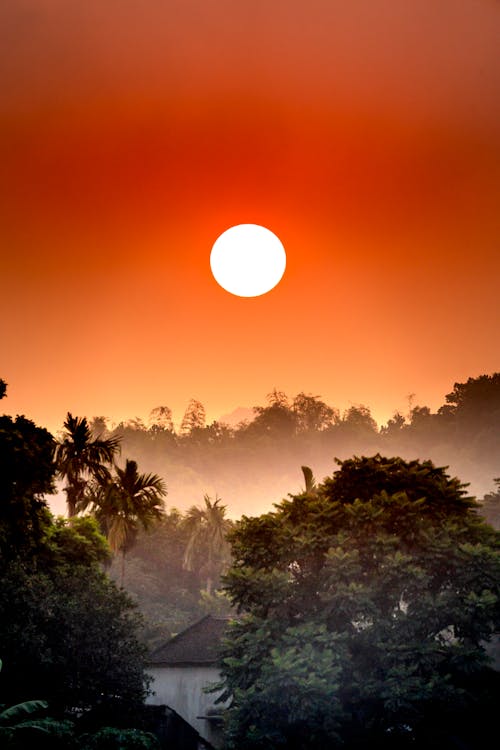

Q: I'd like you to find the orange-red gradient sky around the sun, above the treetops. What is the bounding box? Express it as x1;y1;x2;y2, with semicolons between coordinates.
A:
0;0;500;430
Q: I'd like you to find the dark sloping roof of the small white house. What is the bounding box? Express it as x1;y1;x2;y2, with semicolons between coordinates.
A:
149;615;229;666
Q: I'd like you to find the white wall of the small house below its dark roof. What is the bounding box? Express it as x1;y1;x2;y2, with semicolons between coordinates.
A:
147;666;221;747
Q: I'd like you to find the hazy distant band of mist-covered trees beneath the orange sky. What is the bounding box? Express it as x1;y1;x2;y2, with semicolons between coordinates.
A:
81;373;500;518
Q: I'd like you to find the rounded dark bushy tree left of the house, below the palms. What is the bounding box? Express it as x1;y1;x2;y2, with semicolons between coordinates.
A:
0;518;147;717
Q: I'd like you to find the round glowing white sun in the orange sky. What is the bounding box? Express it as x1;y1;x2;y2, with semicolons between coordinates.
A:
210;224;286;297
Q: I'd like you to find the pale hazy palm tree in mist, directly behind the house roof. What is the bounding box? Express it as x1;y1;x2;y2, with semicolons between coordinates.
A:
183;495;232;595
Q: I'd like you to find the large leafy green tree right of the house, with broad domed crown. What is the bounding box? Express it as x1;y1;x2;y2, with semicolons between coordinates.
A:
222;455;500;750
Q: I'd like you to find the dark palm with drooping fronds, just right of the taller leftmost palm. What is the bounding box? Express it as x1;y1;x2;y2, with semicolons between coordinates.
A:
84;459;167;586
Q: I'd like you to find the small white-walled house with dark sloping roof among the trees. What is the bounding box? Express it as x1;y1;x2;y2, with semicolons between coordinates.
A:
147;615;228;748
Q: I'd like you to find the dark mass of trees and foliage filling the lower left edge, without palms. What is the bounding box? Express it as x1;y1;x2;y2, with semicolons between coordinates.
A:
0;390;155;748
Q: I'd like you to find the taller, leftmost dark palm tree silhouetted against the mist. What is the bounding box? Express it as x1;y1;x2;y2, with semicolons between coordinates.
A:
55;412;120;518
